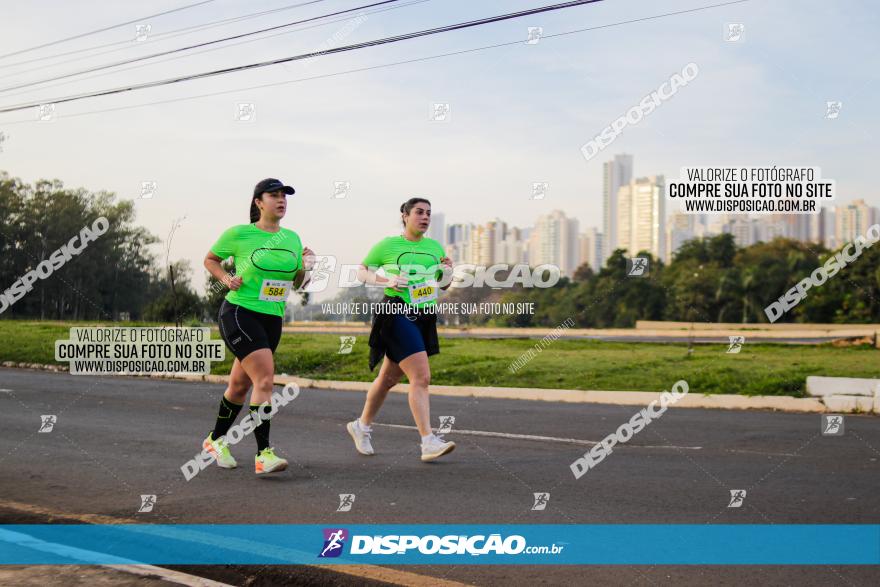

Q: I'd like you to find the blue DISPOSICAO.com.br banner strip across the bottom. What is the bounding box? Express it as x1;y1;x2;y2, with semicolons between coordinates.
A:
0;524;880;565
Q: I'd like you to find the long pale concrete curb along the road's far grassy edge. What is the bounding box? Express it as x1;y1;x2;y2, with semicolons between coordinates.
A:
0;361;840;413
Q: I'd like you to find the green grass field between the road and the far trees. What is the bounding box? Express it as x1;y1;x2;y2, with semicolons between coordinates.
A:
0;320;880;396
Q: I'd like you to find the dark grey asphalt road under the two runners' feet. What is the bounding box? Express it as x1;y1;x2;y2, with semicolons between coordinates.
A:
0;369;880;585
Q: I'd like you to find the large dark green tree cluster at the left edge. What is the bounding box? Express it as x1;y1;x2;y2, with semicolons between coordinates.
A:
0;172;156;320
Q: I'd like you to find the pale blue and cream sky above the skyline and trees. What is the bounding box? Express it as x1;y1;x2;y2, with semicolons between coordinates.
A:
0;0;880;296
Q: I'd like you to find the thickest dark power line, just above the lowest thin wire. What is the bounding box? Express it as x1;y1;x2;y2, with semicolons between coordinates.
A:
0;0;604;113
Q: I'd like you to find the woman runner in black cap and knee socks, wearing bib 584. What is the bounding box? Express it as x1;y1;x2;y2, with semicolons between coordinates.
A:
202;178;315;475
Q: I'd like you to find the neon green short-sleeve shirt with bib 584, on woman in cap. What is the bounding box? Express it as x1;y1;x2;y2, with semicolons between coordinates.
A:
211;224;303;317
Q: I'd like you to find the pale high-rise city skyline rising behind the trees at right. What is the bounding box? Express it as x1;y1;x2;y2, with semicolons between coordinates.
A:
427;189;880;277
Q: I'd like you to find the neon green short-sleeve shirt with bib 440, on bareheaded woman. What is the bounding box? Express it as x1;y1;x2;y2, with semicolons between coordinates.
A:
362;236;446;308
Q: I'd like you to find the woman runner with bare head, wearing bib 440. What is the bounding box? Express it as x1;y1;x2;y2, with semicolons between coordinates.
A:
346;198;455;461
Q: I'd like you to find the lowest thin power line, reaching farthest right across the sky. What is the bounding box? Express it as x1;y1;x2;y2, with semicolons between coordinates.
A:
4;0;749;121
